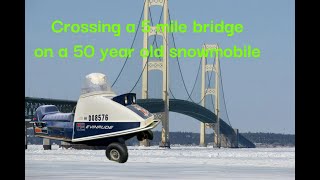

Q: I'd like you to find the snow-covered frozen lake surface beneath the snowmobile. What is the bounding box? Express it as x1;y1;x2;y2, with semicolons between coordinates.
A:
25;145;295;180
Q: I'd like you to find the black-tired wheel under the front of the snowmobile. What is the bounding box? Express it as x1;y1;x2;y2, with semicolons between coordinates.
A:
106;142;128;163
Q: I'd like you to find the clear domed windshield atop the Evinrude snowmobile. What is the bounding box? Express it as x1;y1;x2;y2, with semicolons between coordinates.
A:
81;73;114;94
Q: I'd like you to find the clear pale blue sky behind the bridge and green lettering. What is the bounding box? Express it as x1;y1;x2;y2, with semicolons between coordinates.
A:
25;0;295;134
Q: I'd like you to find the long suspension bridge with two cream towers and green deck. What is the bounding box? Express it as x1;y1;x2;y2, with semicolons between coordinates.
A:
25;0;255;148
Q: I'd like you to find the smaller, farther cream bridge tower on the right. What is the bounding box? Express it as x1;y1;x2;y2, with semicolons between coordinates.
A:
200;44;221;147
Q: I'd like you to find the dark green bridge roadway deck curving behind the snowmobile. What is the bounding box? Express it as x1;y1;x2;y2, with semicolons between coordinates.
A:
25;97;255;148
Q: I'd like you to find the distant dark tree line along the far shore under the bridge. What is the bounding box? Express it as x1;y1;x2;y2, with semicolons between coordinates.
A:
27;128;295;147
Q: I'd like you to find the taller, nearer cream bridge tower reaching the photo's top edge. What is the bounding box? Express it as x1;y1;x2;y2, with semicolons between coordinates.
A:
140;0;170;148
